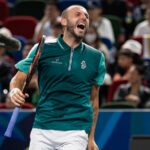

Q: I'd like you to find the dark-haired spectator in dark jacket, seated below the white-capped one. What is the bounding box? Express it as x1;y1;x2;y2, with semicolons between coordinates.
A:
114;65;150;108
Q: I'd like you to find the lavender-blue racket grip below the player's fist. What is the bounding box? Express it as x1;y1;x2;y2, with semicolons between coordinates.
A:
4;107;20;138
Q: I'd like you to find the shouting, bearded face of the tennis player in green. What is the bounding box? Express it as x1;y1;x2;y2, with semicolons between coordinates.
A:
62;7;89;39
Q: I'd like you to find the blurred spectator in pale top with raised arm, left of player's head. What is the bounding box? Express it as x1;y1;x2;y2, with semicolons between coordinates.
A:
33;1;60;41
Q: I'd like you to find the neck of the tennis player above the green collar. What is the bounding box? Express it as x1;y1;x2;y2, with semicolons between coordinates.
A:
63;33;82;49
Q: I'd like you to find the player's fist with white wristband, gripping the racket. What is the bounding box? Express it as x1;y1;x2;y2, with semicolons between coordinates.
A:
9;88;29;107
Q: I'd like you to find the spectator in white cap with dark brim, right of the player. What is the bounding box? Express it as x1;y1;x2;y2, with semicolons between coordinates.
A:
113;40;142;81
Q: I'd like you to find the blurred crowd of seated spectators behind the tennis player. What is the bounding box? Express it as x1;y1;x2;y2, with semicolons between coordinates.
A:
0;0;150;108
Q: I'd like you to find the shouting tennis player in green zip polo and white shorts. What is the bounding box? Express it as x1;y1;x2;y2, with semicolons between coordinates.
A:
10;5;105;150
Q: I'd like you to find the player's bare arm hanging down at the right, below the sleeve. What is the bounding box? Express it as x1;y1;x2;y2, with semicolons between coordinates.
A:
88;85;99;150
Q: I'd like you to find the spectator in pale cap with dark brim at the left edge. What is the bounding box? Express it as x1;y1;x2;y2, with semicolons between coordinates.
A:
0;28;20;102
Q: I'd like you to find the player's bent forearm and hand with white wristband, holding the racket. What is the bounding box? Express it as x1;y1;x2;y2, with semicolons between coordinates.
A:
9;71;28;107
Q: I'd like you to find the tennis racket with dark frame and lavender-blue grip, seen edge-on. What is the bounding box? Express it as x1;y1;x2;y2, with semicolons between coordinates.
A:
4;35;46;137
